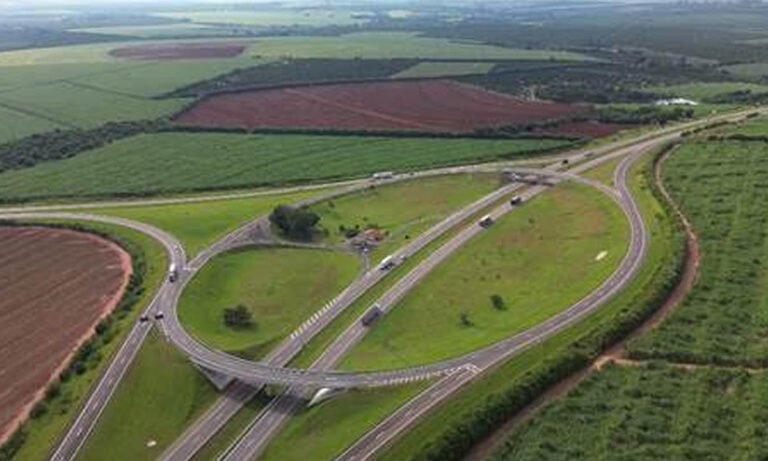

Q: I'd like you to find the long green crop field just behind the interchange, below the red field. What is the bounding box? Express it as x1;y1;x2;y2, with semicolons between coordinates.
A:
0;133;570;200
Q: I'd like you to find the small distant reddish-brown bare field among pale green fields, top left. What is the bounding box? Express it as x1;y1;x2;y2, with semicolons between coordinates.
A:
109;43;247;59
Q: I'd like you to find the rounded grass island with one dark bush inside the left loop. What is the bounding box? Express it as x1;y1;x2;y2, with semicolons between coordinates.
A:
179;248;361;358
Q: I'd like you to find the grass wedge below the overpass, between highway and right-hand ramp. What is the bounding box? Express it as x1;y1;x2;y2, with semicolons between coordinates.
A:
260;383;429;461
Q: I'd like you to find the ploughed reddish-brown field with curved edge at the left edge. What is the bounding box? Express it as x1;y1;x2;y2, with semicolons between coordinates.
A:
0;227;131;442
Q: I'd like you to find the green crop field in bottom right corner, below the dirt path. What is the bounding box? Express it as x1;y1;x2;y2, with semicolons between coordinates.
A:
492;365;768;461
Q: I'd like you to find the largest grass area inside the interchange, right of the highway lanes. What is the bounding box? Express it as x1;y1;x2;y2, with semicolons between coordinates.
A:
341;184;628;369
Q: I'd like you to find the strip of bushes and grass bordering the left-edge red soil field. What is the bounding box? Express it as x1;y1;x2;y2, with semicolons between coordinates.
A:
0;221;146;461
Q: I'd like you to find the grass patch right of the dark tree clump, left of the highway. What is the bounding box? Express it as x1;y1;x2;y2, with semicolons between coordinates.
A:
312;174;501;263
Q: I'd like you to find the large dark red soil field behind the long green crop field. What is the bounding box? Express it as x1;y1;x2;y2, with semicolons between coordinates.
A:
176;80;587;133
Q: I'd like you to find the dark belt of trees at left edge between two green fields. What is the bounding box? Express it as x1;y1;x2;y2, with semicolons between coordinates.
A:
0;121;167;173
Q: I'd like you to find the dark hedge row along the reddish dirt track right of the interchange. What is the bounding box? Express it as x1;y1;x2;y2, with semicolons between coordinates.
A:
413;148;686;461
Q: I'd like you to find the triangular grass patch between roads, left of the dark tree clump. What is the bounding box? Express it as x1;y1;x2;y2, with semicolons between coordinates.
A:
87;191;323;258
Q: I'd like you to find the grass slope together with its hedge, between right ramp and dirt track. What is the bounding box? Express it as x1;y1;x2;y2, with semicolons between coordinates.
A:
379;150;684;461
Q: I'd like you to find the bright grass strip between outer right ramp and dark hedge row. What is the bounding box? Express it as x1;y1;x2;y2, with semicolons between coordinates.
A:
378;147;680;461
